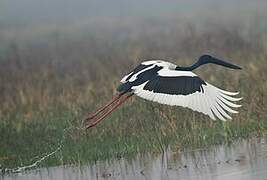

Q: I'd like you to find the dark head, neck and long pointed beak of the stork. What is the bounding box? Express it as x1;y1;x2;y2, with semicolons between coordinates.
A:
176;55;242;71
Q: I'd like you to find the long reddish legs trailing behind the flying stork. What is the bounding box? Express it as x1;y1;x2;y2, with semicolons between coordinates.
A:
84;93;133;129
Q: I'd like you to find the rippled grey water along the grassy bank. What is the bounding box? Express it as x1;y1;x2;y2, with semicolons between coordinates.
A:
0;139;267;180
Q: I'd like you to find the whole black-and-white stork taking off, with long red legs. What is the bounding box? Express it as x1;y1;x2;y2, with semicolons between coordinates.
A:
85;55;242;128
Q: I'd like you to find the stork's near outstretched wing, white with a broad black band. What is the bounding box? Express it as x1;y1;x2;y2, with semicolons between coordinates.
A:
132;68;242;121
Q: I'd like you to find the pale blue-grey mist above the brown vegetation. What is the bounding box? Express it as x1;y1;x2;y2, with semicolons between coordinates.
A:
0;0;267;38
